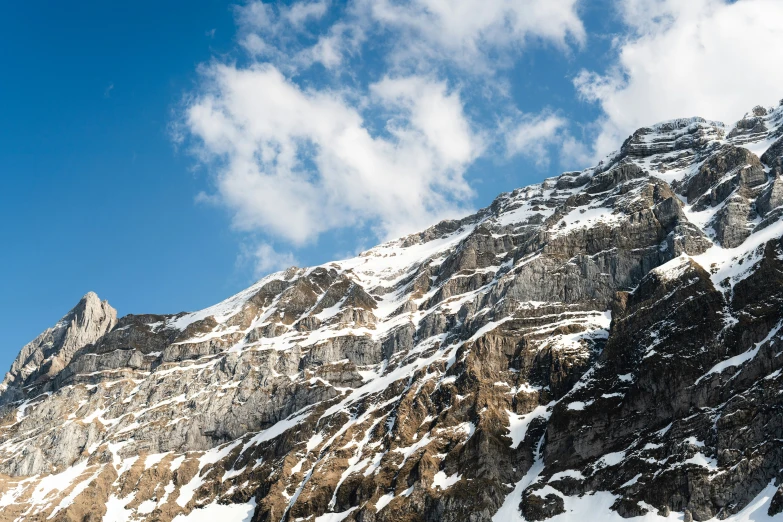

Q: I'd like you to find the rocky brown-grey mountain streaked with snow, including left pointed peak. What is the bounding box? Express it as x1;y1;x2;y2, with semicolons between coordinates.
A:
0;102;783;522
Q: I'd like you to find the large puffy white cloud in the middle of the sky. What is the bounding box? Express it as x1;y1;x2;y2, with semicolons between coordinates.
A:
185;64;482;245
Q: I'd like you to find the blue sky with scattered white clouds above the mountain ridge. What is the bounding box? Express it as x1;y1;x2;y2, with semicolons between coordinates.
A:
0;0;783;367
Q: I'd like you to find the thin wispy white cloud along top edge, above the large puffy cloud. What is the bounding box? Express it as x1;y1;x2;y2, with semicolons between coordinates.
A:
236;0;586;74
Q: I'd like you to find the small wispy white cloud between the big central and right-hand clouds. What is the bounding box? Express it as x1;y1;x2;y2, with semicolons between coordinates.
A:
505;112;568;166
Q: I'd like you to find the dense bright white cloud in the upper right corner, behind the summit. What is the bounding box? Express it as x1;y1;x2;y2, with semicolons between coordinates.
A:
575;0;783;156
